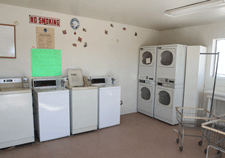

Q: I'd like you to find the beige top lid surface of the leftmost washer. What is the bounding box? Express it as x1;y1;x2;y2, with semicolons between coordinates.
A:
0;87;31;95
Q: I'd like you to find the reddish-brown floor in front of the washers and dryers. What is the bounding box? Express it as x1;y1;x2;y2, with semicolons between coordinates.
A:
0;113;219;158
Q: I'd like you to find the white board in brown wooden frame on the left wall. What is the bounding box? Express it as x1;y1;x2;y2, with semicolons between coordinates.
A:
0;24;16;58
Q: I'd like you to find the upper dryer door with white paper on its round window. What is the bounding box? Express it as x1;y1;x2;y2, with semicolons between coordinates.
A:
139;48;156;67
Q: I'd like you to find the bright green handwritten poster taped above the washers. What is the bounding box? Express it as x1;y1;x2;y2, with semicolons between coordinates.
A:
31;49;62;77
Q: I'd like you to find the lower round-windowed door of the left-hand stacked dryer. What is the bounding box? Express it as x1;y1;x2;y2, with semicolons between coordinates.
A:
139;85;153;101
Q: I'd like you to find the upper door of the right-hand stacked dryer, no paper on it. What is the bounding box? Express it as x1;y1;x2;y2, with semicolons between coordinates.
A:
158;48;176;68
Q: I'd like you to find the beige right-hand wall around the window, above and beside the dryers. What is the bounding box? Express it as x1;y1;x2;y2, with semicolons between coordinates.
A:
159;22;225;112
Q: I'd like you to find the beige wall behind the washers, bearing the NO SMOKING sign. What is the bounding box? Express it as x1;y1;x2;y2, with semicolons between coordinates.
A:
0;4;159;114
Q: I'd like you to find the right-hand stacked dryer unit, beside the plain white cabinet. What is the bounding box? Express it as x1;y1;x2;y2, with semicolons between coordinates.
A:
154;45;187;125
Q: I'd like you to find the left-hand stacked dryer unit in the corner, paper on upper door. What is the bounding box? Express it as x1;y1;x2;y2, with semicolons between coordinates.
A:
138;46;157;117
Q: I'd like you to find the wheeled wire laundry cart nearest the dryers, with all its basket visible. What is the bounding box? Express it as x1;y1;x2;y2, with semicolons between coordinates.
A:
176;107;217;151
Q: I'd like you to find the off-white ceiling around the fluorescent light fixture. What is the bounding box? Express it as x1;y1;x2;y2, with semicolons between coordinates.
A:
0;0;225;30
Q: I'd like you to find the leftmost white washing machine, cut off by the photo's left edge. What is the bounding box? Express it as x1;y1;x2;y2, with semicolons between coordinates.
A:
0;78;34;149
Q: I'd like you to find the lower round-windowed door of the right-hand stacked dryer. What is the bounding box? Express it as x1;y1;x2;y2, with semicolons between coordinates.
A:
156;87;173;108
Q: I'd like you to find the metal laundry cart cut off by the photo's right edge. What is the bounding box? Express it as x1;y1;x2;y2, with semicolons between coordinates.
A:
202;119;225;158
